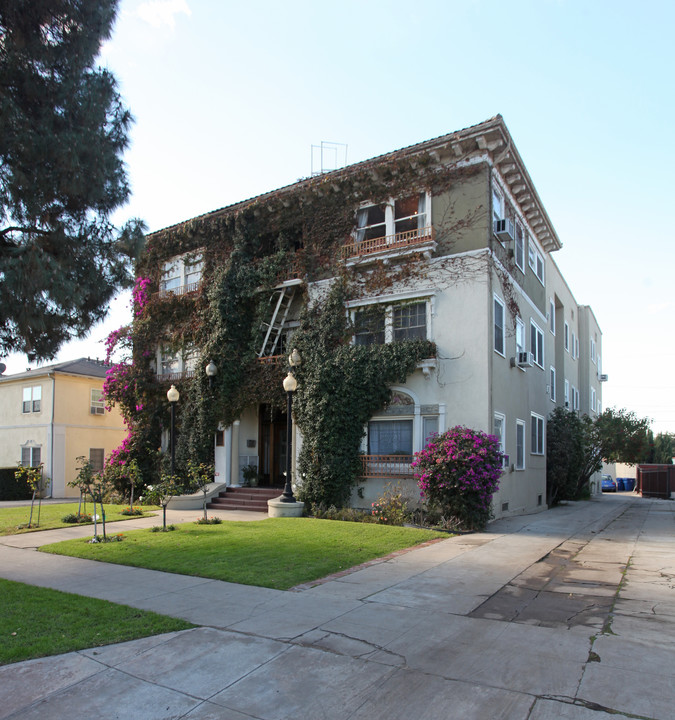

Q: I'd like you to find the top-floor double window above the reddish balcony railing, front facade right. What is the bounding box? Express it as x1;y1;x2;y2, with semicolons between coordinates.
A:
355;193;429;243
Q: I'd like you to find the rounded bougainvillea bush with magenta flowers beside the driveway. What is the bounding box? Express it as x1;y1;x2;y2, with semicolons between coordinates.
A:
412;425;503;530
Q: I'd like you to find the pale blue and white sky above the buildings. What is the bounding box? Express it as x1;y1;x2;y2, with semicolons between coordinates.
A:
4;0;675;432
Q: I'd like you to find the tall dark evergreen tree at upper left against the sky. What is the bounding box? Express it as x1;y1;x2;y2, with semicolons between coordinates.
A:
0;0;143;360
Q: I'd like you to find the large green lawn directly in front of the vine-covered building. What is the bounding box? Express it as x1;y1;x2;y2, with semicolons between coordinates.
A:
41;518;438;590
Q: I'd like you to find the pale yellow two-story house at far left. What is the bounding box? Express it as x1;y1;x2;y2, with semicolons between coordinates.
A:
0;358;126;498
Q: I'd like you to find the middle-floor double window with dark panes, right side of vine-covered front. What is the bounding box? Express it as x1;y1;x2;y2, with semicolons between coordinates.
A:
352;299;429;345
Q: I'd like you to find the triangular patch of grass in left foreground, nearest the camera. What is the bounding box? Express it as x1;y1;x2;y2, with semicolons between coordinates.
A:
0;579;194;665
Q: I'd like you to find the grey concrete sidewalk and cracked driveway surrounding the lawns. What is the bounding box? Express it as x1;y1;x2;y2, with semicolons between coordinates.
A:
0;494;675;720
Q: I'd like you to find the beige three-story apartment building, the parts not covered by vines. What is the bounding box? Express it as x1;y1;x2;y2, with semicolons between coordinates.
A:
149;116;606;517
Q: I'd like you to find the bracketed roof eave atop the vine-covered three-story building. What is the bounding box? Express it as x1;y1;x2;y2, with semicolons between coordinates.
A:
148;115;562;252
